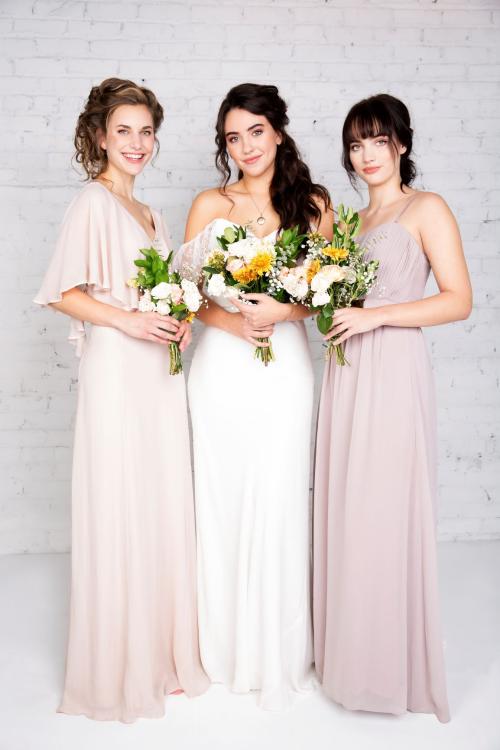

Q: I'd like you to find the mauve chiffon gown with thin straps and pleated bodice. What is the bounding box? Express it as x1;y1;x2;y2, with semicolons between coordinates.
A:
313;199;449;721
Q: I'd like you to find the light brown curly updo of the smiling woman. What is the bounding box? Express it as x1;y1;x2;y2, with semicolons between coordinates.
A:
74;78;163;180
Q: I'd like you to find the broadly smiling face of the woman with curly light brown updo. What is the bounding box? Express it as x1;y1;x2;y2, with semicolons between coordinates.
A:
99;104;155;177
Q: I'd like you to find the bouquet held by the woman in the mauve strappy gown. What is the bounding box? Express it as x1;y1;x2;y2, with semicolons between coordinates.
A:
286;205;379;365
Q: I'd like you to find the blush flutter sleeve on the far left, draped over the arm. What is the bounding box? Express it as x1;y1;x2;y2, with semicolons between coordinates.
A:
34;185;135;356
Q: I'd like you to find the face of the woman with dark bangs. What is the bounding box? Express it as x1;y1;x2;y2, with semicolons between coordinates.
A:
349;134;406;186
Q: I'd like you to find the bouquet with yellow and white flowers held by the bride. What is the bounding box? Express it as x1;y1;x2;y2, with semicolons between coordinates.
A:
203;225;305;367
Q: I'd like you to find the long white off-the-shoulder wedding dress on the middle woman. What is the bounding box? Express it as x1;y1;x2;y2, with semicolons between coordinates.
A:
175;219;313;710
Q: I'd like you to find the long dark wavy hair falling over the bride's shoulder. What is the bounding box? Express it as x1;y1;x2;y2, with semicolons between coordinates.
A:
215;83;331;232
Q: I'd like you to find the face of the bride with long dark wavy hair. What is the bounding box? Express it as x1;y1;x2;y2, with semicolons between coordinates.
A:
224;109;282;177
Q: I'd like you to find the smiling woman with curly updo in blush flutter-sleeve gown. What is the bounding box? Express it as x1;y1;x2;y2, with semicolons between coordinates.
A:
35;79;208;722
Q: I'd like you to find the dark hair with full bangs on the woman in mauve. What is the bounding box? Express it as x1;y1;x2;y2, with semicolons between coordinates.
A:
342;94;417;188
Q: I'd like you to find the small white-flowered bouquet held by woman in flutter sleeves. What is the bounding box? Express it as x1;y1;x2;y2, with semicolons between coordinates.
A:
127;247;202;375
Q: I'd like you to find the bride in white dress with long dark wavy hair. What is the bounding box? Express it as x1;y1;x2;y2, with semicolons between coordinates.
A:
176;83;333;709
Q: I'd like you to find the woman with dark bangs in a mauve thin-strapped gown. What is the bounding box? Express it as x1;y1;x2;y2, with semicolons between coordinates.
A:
314;94;471;721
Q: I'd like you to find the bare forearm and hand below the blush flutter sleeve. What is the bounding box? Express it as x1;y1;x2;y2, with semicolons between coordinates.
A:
50;287;191;351
